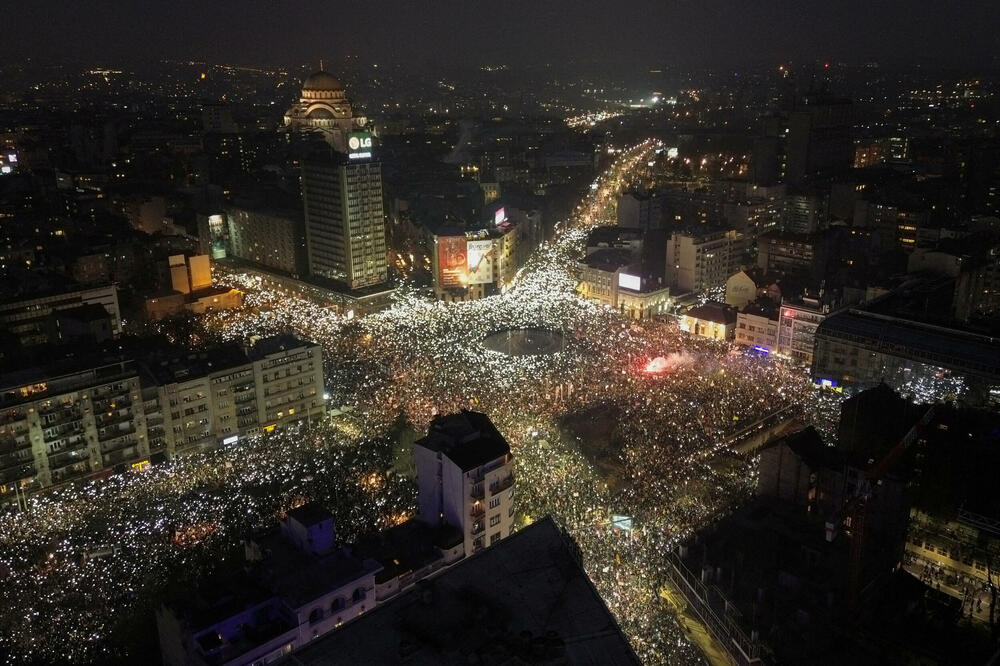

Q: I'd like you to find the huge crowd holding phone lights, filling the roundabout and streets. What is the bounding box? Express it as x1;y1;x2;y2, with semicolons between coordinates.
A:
0;141;838;663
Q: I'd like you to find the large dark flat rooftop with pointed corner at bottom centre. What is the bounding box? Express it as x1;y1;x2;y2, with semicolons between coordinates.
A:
281;518;639;666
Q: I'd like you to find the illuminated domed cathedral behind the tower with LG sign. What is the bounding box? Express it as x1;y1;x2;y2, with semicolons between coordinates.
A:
285;63;368;153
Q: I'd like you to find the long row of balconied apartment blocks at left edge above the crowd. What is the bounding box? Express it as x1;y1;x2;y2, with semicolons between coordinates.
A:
0;335;325;504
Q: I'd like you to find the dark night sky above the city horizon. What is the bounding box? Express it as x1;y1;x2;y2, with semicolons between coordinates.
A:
0;0;1000;66
